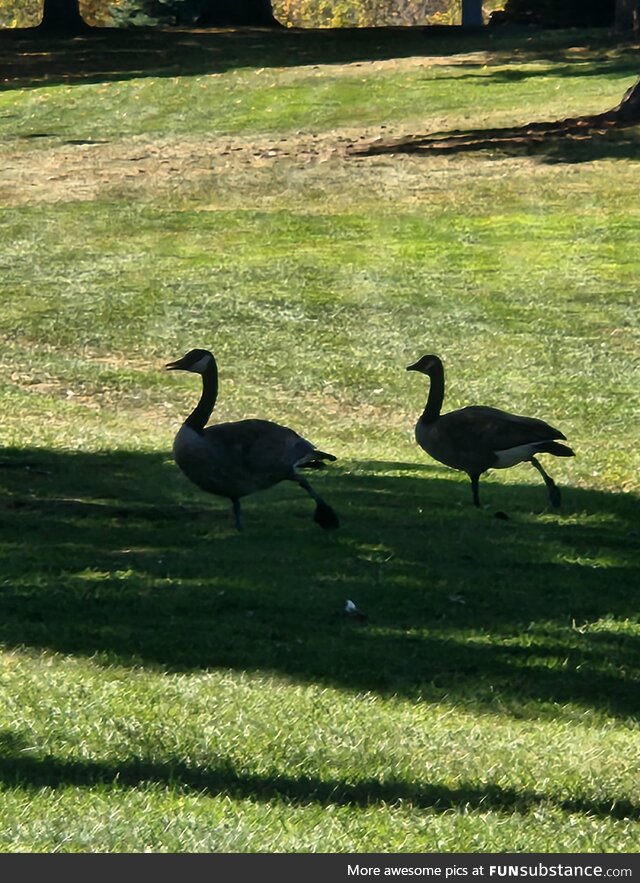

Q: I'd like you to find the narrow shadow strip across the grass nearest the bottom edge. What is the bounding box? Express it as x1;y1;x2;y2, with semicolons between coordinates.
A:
0;731;640;820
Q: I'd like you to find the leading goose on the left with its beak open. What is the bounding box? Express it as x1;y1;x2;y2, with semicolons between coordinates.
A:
165;349;339;531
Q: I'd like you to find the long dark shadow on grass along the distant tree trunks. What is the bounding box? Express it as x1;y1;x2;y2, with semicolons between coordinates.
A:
0;26;633;89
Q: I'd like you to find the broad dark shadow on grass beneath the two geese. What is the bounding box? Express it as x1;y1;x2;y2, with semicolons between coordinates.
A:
0;450;640;717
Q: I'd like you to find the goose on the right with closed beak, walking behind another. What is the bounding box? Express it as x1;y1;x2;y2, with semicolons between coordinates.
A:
407;355;575;508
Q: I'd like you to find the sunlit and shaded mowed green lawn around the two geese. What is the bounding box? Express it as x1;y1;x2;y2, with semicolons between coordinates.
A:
0;31;640;852
